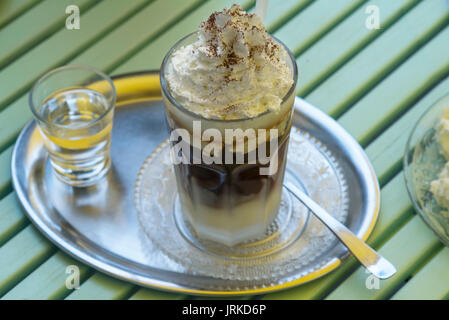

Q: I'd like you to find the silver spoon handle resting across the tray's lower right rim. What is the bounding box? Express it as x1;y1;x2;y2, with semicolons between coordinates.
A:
284;182;396;279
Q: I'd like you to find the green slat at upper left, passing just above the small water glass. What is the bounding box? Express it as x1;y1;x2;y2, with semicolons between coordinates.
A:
0;0;148;112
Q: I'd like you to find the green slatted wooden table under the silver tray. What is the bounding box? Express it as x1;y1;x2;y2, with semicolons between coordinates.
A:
0;0;449;299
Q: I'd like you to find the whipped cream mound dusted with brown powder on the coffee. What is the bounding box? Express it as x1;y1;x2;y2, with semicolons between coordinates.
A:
166;5;293;120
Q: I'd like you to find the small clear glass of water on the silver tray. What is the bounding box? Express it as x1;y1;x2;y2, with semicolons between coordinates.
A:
29;66;116;187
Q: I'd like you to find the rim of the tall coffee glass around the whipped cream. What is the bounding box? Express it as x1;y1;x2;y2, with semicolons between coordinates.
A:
159;31;298;123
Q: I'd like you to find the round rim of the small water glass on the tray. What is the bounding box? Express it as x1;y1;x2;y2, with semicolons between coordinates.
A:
28;65;117;127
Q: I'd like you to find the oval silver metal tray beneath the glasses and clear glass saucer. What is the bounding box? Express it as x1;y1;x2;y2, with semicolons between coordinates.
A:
11;71;380;295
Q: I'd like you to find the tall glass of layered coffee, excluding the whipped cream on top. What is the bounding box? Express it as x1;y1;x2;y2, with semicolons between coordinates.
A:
160;33;298;246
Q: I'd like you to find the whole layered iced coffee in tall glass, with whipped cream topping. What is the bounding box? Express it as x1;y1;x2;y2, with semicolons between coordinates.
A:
161;5;297;246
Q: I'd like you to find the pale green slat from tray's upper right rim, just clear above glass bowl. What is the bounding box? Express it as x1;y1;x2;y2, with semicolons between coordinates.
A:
338;27;449;145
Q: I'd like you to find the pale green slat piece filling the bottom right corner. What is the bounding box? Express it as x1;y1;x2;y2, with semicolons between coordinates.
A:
392;248;449;300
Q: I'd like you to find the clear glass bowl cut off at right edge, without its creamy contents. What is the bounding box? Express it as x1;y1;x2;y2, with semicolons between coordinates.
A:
404;93;449;246
